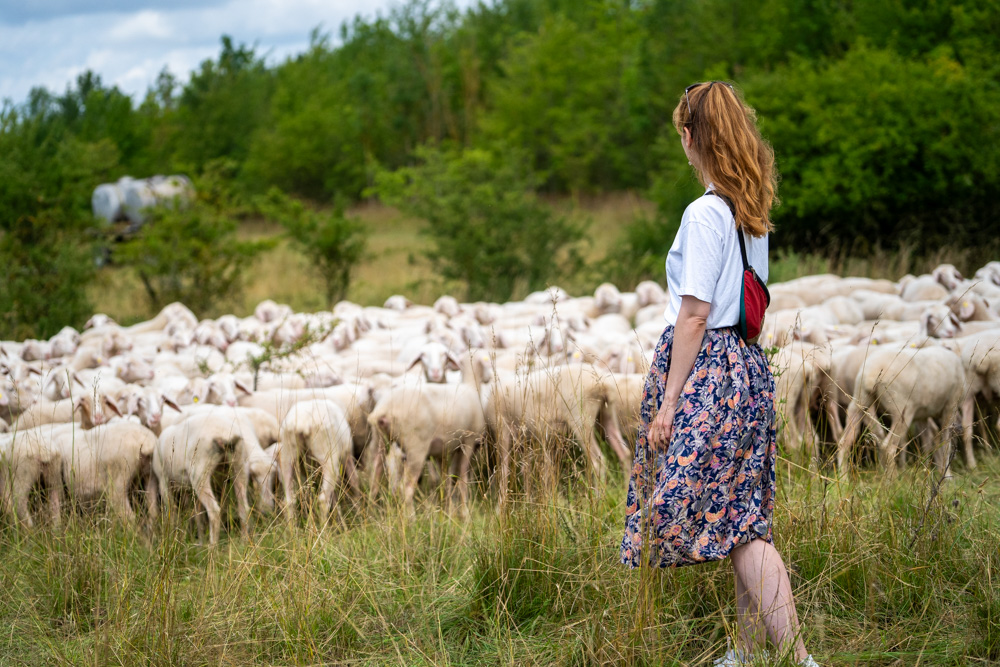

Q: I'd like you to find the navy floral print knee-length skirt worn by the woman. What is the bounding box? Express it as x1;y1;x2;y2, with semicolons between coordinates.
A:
621;326;777;567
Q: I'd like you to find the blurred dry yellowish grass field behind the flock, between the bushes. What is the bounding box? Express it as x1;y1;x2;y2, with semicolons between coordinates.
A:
90;193;992;323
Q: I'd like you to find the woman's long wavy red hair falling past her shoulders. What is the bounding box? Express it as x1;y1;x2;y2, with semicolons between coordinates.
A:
673;81;778;237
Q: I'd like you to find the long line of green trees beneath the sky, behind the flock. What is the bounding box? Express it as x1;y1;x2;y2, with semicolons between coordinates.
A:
0;0;1000;340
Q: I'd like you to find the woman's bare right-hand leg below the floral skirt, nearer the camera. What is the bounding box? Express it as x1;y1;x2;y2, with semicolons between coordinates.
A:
730;539;808;662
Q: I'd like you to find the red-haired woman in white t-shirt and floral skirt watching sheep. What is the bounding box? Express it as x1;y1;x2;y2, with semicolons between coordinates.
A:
621;81;816;666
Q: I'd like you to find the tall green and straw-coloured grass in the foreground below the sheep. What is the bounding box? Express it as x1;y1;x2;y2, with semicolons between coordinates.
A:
0;455;1000;665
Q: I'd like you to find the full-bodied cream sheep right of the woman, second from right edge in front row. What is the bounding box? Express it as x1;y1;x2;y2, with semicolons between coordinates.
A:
837;346;965;475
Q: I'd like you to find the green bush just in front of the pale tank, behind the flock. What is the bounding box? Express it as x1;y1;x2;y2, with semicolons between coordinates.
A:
114;162;274;313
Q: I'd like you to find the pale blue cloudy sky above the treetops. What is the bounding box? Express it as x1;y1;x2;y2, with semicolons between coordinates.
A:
0;0;473;103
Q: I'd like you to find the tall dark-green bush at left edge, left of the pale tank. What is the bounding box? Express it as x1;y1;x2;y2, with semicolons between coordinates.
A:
0;103;118;338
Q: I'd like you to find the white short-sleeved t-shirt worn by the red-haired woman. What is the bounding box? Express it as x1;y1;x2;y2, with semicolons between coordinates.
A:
663;185;767;329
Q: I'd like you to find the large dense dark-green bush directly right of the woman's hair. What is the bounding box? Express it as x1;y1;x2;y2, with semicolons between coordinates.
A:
746;42;1000;254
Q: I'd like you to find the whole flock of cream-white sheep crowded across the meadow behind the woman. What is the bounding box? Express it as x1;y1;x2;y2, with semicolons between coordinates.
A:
0;262;1000;543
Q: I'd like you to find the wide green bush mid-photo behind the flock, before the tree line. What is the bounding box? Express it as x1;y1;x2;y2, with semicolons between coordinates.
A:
375;147;583;301
